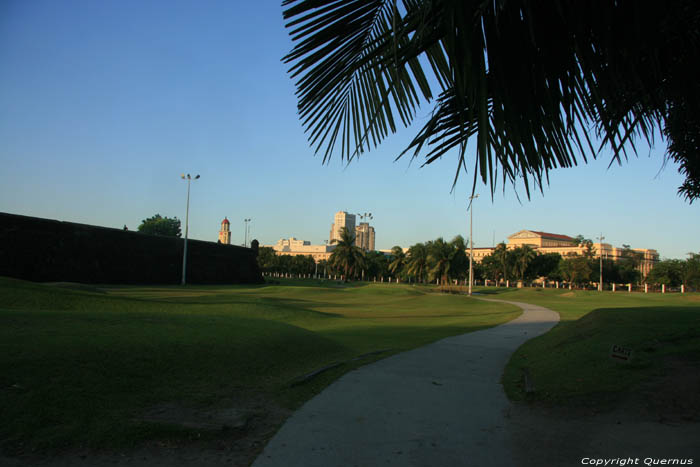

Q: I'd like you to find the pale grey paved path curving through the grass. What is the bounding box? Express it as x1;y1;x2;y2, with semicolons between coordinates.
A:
253;300;559;467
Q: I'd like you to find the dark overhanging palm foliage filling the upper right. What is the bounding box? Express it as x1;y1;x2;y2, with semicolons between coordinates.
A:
283;0;700;202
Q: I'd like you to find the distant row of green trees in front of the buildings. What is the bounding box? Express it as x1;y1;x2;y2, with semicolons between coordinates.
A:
258;229;700;288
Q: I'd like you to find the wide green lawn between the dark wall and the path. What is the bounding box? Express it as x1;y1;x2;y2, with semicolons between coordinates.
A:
0;278;520;452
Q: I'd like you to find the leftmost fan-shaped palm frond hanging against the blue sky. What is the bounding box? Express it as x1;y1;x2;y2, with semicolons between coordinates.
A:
283;0;431;162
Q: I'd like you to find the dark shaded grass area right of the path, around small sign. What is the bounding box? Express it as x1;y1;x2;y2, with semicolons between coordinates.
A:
503;306;700;407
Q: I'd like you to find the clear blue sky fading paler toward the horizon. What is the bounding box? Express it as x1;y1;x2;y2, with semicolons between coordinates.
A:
0;0;700;258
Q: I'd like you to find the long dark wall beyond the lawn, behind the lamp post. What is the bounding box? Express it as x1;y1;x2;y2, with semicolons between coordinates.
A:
0;213;263;284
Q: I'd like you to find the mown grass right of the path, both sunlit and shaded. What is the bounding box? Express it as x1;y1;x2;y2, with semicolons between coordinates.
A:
484;289;700;408
